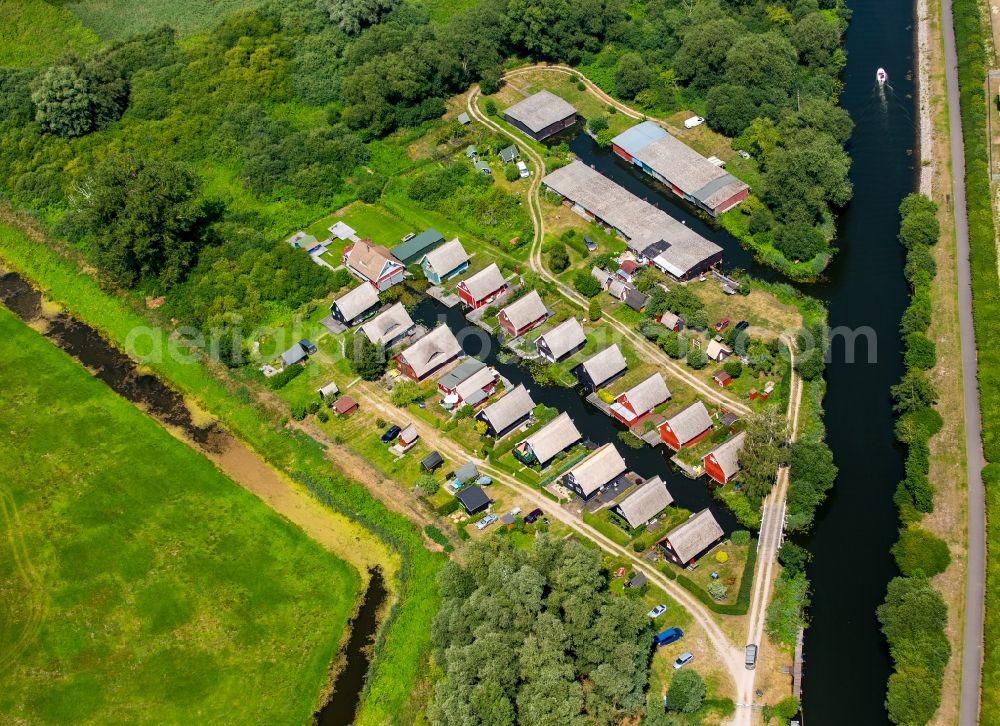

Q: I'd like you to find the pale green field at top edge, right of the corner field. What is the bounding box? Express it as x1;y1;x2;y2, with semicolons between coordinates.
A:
66;0;261;39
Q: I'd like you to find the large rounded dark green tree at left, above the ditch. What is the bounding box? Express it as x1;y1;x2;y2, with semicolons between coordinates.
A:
76;154;208;287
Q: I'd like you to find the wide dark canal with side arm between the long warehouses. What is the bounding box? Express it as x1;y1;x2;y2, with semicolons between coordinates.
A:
570;0;917;726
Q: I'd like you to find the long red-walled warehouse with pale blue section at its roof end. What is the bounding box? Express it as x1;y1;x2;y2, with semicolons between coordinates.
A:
611;121;750;217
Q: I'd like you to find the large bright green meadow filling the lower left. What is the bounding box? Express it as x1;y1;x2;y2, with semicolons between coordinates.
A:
0;309;360;724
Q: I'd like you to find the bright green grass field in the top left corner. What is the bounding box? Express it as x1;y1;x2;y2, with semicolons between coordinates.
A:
0;0;98;68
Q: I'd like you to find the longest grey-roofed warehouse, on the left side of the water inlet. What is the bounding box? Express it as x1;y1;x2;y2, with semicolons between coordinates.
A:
542;160;722;280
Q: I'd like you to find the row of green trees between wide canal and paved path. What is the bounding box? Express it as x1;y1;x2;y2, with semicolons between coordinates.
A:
878;194;951;725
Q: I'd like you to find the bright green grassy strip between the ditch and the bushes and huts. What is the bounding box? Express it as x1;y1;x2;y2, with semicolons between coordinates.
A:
0;219;444;723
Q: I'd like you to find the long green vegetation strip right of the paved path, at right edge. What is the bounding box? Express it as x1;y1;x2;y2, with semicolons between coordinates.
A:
952;0;1000;714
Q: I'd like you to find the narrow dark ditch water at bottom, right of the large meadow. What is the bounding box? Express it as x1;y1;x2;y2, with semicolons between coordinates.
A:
315;568;388;726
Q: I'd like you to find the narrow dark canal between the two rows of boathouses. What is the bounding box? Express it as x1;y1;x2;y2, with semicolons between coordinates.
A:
413;298;740;534
